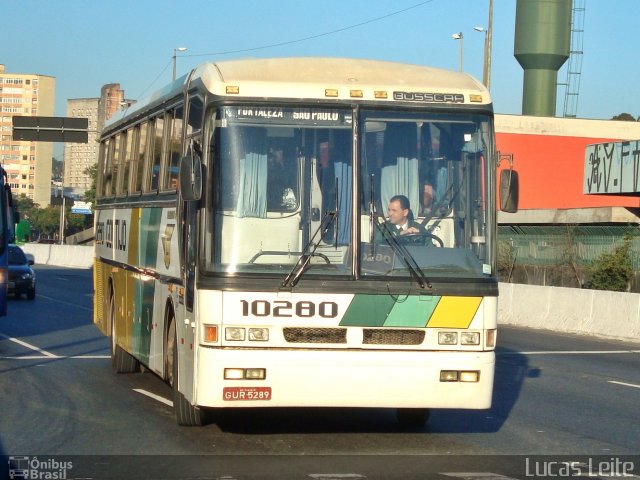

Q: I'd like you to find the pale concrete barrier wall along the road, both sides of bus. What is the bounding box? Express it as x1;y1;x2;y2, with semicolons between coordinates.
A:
23;243;640;342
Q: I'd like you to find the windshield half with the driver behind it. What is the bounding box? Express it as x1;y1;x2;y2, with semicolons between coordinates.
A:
360;111;493;278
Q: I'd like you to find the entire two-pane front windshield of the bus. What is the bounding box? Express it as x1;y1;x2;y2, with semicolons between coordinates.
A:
205;106;494;280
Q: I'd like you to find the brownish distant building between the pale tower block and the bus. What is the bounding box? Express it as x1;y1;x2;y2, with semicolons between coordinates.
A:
64;83;125;199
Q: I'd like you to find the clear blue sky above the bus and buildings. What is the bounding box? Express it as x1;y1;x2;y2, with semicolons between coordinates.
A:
0;0;640;124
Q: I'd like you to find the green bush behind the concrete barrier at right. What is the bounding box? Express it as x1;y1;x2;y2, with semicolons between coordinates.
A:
590;235;633;292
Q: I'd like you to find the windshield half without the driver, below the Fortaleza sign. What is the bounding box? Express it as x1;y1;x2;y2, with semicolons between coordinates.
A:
207;106;353;276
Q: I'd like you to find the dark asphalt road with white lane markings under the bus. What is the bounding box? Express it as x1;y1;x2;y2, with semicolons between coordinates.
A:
0;266;640;480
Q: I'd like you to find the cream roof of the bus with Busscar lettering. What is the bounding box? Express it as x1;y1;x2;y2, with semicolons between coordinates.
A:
107;57;491;133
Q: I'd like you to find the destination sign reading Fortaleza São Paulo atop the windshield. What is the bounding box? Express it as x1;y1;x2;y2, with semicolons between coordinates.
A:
225;106;353;126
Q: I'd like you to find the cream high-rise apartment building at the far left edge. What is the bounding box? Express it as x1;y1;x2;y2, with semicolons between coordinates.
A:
0;64;56;207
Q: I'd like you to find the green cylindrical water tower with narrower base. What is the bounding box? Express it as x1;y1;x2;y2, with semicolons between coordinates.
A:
514;0;571;117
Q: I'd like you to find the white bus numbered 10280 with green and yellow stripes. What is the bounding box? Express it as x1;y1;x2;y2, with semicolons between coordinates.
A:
94;58;517;425
